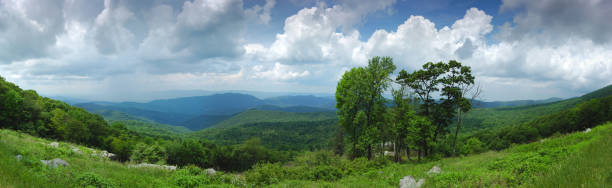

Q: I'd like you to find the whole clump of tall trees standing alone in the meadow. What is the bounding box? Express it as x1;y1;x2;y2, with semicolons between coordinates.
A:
336;57;474;160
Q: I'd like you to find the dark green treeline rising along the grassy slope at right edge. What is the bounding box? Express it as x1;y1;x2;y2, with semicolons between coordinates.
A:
465;94;612;150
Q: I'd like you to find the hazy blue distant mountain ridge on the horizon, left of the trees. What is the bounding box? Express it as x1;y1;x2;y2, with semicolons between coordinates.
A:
76;93;335;130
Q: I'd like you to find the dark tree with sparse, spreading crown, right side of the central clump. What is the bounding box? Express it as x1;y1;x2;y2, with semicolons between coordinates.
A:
396;60;474;155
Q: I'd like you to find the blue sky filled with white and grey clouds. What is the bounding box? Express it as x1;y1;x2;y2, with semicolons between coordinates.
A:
0;0;612;101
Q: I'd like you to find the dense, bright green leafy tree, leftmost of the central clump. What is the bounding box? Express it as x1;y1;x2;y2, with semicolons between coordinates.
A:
336;57;395;158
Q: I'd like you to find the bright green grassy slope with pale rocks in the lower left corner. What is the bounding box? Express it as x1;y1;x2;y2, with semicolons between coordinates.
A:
0;130;243;187
